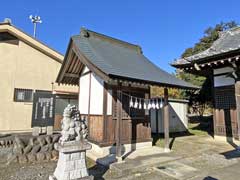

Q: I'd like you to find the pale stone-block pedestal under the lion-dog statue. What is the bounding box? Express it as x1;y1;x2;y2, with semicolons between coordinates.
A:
49;140;93;180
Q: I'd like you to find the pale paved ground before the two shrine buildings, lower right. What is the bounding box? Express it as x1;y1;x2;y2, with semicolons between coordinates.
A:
104;136;240;180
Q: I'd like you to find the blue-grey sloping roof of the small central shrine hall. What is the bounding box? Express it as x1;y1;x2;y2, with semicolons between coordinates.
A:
72;29;197;88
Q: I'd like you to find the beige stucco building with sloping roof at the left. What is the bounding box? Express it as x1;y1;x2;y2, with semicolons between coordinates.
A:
0;22;78;133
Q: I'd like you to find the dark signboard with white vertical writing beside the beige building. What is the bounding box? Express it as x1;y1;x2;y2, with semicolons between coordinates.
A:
32;92;56;127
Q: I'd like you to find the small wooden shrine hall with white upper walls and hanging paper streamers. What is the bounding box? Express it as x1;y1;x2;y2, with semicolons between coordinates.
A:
57;29;197;156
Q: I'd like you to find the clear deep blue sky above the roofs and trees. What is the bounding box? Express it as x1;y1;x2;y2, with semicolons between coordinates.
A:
0;0;240;72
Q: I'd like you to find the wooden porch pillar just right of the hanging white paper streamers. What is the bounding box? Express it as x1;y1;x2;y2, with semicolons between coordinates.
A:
164;88;170;152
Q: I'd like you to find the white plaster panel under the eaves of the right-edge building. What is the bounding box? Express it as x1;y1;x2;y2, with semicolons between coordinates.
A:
213;67;235;87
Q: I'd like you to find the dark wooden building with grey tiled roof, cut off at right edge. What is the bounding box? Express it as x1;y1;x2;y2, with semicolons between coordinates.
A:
172;27;240;140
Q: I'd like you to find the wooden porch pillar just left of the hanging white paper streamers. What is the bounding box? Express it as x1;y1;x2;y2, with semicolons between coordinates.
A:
116;85;122;161
